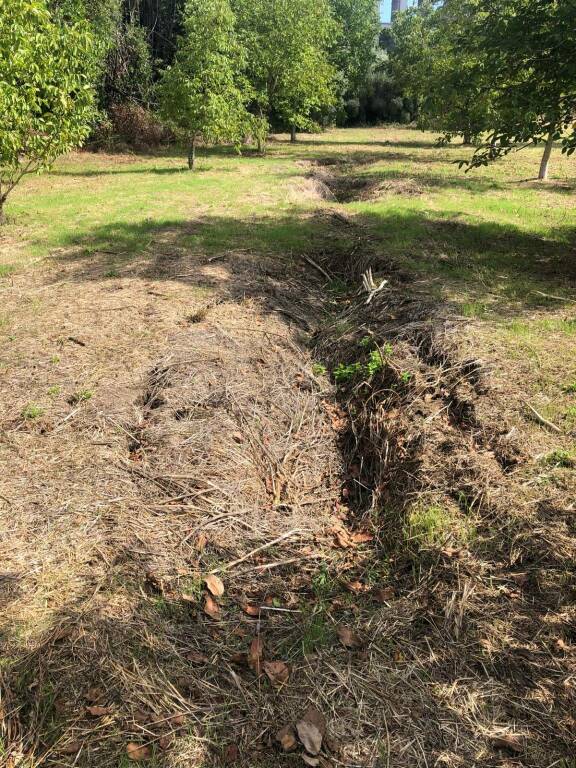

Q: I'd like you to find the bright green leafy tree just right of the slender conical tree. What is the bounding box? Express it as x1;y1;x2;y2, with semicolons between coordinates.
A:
234;0;337;140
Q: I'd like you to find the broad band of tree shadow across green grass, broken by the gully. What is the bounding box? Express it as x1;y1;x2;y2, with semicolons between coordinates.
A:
46;204;576;313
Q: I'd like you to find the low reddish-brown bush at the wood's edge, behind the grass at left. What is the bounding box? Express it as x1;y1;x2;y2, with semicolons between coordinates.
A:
90;103;174;151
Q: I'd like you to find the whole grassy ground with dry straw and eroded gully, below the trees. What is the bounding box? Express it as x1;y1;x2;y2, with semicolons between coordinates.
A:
0;127;576;768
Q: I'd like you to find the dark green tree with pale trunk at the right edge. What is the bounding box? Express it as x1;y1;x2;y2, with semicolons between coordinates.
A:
460;0;576;179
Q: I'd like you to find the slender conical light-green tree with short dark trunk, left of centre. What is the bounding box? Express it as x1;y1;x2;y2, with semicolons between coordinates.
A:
158;0;248;170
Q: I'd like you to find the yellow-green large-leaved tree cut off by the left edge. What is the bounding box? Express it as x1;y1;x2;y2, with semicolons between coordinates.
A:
0;0;96;220
